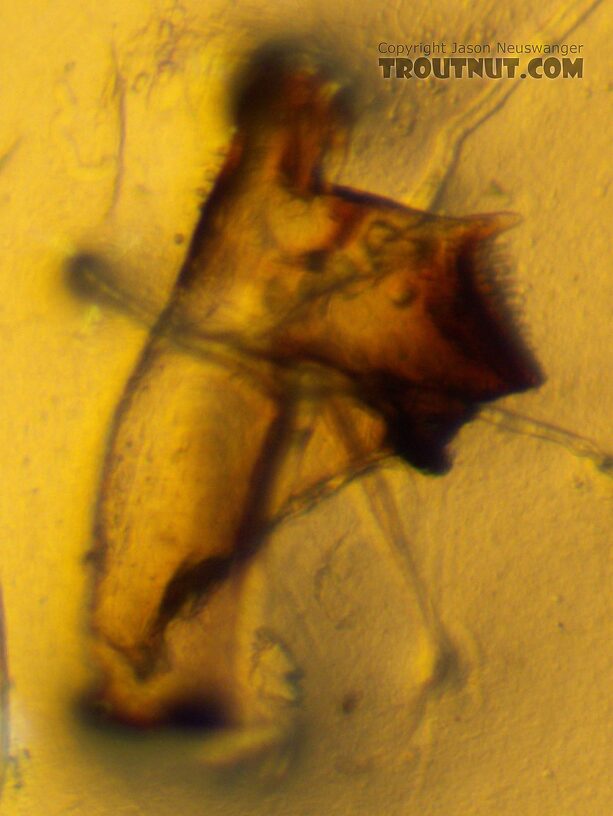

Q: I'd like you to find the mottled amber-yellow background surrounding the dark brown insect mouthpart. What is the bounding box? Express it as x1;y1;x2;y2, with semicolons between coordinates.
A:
0;0;613;816
